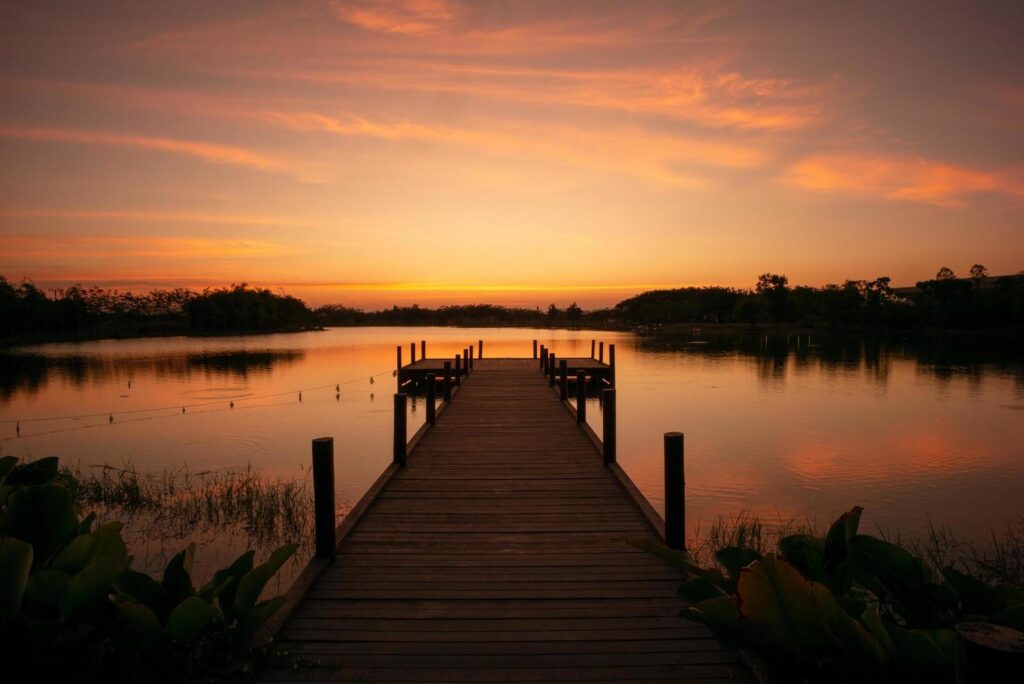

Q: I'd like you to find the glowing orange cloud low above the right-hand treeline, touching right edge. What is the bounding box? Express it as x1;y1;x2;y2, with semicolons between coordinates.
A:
788;153;1024;207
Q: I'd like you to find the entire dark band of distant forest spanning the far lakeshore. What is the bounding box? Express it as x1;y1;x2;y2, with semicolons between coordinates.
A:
0;264;1024;342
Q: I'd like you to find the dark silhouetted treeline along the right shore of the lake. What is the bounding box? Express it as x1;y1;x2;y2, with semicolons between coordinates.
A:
614;264;1024;329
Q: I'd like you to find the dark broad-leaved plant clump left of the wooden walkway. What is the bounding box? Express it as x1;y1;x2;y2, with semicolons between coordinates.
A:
0;457;295;682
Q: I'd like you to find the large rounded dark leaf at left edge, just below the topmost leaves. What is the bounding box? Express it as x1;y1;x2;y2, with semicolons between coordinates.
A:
6;481;78;567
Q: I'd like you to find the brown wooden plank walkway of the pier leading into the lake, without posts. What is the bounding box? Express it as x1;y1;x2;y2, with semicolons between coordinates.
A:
261;359;749;683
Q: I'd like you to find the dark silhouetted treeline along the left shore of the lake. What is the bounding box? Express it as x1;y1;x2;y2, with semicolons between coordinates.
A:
0;276;315;341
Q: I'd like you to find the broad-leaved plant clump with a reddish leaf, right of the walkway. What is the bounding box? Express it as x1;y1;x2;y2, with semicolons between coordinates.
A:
637;507;1024;681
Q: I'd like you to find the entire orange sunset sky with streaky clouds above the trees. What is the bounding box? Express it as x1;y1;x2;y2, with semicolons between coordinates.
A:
0;0;1024;306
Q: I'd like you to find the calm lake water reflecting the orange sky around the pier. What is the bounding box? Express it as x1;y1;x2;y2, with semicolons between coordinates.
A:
0;328;1024;577
